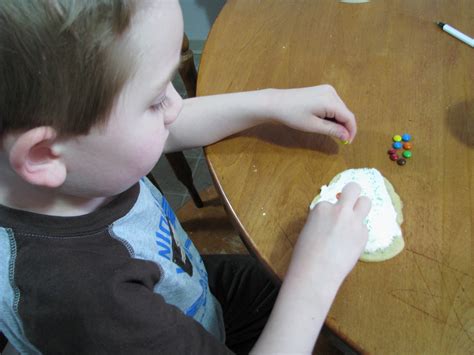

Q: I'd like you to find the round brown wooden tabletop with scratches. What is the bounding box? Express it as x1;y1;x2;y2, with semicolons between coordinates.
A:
198;0;474;354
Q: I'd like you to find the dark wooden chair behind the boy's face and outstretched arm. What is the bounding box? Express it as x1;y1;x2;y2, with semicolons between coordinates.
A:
148;34;203;208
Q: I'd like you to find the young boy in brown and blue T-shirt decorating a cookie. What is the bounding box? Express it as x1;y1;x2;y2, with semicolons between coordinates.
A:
0;0;370;354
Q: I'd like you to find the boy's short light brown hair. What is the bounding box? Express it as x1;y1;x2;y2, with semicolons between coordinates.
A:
0;0;134;137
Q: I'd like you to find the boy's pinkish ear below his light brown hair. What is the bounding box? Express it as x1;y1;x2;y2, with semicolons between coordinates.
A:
8;127;66;188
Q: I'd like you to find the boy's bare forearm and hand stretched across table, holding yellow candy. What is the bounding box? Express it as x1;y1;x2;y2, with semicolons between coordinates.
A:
165;85;357;152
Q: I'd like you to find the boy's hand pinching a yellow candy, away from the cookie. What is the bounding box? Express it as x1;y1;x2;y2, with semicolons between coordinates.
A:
271;85;357;142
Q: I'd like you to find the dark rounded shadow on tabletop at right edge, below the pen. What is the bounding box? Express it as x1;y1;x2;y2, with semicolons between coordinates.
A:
446;100;474;148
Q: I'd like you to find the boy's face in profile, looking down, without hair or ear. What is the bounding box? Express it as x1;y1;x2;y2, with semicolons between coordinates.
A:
59;0;183;197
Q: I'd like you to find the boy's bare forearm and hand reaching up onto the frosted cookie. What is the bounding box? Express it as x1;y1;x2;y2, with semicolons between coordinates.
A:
252;183;371;354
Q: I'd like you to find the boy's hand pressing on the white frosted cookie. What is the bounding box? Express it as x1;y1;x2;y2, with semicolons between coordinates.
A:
293;183;371;282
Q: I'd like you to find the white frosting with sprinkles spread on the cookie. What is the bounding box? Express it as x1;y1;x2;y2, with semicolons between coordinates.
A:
311;168;402;253
